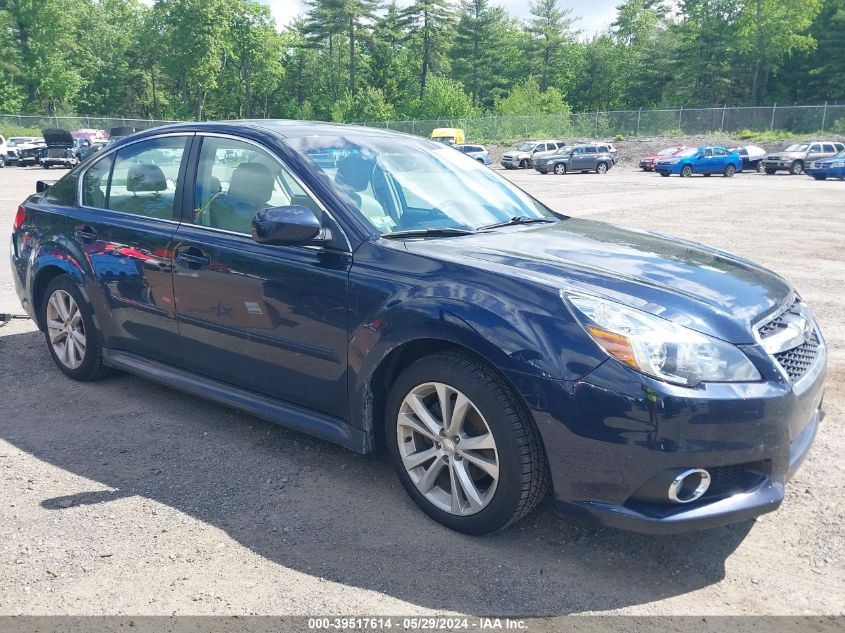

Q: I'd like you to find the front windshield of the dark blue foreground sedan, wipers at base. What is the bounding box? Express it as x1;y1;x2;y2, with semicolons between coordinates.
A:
287;136;555;233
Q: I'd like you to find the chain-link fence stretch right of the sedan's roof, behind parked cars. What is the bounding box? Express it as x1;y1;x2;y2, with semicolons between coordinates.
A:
362;104;845;142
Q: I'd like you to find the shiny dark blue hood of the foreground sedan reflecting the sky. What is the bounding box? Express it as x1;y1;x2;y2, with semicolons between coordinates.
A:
406;218;792;344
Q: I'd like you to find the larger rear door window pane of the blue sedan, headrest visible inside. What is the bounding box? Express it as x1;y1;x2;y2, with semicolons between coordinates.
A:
106;136;186;220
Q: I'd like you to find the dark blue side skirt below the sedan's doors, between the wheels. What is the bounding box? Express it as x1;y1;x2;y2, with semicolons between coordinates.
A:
103;349;369;453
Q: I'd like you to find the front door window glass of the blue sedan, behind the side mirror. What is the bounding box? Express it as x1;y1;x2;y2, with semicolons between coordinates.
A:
193;136;322;235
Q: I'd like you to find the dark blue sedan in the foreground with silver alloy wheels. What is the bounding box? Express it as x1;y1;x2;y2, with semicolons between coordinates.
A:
11;121;826;534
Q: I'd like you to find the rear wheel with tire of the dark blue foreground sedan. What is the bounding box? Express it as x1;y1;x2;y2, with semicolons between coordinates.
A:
39;275;112;381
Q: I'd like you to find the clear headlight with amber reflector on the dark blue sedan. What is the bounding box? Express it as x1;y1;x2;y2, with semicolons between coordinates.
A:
560;290;761;387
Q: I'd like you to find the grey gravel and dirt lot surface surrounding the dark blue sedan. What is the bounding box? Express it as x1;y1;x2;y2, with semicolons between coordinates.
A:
0;168;845;616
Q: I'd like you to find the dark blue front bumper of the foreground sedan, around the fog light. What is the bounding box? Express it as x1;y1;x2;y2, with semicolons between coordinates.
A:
520;344;826;534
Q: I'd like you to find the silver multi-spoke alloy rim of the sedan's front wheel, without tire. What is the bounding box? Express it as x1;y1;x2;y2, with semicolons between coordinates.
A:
396;382;499;516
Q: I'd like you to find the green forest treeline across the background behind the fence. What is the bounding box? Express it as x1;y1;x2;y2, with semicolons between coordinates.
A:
0;0;845;121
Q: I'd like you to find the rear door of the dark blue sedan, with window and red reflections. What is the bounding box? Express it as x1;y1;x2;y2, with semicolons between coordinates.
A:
70;134;193;365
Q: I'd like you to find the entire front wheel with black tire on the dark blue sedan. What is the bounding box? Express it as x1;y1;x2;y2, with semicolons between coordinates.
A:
385;352;550;534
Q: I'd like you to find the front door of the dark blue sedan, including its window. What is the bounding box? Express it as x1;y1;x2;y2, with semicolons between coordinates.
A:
173;135;352;417
